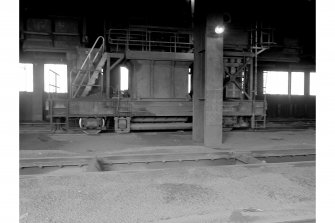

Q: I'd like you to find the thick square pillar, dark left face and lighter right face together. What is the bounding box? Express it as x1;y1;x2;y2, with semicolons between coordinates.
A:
192;6;223;147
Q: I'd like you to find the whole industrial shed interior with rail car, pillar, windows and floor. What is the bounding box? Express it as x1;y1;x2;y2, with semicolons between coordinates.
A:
14;0;319;223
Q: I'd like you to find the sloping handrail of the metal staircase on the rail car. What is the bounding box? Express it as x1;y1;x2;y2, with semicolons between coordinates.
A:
71;36;105;98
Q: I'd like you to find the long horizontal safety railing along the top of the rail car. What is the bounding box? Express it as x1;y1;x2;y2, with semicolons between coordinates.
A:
107;27;193;52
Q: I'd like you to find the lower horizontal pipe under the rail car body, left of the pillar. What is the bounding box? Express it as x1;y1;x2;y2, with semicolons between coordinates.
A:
130;123;192;130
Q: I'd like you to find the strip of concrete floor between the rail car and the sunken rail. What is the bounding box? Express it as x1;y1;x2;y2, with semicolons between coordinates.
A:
20;129;315;158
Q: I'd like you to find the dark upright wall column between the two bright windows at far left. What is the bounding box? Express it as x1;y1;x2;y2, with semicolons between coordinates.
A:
32;63;44;121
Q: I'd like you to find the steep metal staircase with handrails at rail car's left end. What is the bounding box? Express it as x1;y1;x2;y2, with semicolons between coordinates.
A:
71;36;107;98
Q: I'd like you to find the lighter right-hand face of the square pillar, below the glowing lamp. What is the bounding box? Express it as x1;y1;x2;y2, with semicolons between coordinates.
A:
204;13;223;147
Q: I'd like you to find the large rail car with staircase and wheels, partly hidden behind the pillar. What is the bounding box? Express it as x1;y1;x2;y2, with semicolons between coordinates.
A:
48;27;266;132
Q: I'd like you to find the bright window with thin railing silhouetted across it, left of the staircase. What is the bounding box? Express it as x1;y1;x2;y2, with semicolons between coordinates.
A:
44;64;67;93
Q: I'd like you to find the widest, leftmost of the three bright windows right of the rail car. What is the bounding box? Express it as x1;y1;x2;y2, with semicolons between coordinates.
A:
263;71;288;94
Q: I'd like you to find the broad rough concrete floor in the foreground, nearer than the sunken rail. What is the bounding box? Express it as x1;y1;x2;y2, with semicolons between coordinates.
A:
20;162;315;223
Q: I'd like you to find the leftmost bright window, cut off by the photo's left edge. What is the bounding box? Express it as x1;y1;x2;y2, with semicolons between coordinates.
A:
18;63;34;92
